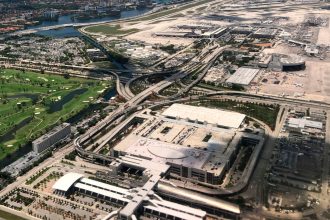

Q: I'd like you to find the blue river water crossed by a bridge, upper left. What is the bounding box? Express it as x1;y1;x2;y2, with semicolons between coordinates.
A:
28;8;151;37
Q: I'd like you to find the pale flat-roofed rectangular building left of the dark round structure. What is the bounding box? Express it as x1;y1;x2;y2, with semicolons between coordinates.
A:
226;67;259;86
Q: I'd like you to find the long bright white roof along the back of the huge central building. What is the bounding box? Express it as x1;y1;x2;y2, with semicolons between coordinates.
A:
162;104;245;128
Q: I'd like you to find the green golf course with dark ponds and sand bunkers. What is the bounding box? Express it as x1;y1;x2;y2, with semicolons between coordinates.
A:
0;69;111;159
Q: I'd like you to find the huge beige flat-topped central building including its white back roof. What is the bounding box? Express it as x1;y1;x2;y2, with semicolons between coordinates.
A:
112;104;245;184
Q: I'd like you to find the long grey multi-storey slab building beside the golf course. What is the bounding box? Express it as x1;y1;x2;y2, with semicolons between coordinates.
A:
32;123;71;153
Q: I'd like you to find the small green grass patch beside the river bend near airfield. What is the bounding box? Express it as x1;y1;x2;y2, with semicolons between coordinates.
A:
85;24;139;36
